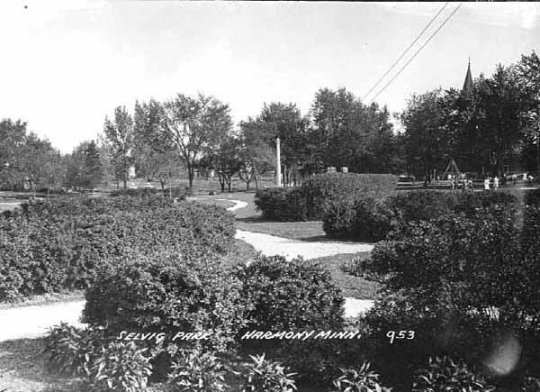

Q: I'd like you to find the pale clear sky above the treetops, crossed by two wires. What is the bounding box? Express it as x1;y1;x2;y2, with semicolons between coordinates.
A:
0;0;540;153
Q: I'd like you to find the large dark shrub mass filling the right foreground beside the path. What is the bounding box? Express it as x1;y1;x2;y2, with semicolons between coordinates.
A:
352;192;540;390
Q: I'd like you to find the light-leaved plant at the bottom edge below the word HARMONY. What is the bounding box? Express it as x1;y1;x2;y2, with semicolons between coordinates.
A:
241;354;296;392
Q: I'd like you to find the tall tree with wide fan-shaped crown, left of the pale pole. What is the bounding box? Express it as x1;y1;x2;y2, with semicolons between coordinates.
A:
162;94;232;188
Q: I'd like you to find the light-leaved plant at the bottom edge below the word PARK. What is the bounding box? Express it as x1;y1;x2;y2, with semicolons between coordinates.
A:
167;350;227;392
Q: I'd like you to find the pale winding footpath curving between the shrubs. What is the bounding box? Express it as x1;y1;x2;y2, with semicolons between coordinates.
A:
0;199;373;341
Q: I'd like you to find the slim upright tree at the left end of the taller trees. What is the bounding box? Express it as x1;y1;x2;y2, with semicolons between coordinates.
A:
104;106;134;189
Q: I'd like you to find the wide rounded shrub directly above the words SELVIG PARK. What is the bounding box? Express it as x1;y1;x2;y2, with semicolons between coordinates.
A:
83;250;246;349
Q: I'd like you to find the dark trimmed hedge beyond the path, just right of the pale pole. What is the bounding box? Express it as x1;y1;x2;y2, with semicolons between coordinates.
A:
255;173;397;221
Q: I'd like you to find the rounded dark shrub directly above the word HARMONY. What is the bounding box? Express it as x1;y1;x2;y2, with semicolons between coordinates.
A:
237;256;344;331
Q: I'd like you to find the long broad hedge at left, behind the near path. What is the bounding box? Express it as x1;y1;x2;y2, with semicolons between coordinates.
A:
0;197;234;301
